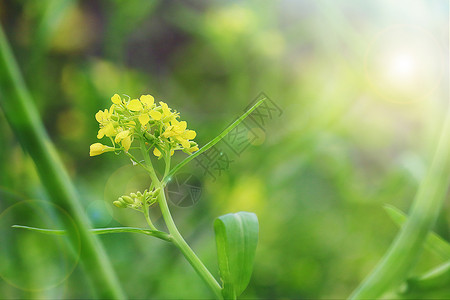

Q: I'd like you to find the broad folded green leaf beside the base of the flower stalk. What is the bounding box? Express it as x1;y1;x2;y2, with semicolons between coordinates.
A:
214;212;259;299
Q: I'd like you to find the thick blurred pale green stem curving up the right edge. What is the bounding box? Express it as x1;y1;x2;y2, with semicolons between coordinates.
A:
350;74;450;299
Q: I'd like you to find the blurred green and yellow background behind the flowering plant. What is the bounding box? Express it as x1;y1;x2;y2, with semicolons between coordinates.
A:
0;0;449;299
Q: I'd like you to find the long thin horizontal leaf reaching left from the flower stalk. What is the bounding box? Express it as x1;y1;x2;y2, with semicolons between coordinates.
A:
12;225;171;242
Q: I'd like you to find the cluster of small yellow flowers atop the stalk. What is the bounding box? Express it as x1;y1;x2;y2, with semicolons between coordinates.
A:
90;94;198;157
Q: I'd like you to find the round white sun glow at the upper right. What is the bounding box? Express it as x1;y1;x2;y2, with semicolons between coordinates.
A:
366;26;443;102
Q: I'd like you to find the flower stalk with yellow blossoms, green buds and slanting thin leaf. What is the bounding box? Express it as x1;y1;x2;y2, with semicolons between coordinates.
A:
86;94;264;299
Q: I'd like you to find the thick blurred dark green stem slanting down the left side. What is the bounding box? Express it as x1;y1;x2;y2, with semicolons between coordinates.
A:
0;22;124;299
